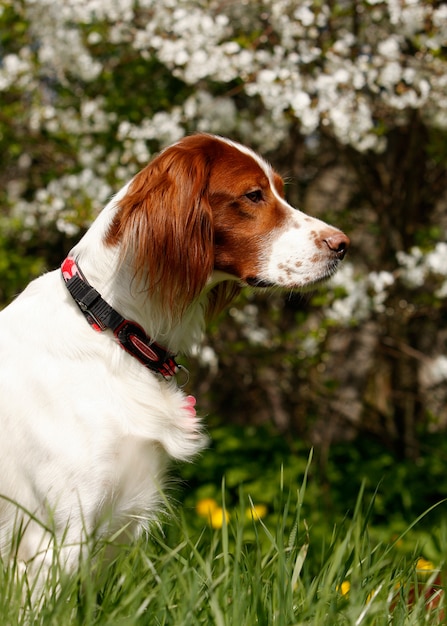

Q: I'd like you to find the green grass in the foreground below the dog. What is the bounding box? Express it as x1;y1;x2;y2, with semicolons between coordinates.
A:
0;450;447;626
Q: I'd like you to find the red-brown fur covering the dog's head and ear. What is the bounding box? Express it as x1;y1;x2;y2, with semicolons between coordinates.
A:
106;135;285;315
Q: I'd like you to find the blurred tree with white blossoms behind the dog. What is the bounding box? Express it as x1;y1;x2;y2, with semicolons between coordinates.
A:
0;0;447;453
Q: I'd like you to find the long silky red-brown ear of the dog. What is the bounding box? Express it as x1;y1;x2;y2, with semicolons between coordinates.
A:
107;144;214;317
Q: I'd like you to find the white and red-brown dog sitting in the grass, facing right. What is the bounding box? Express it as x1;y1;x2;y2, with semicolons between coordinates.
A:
0;134;349;584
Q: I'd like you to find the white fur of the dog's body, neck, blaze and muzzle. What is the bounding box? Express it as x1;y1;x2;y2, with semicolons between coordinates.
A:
0;134;350;588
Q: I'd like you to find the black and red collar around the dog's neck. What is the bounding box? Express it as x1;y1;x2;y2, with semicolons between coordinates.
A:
61;257;181;378
